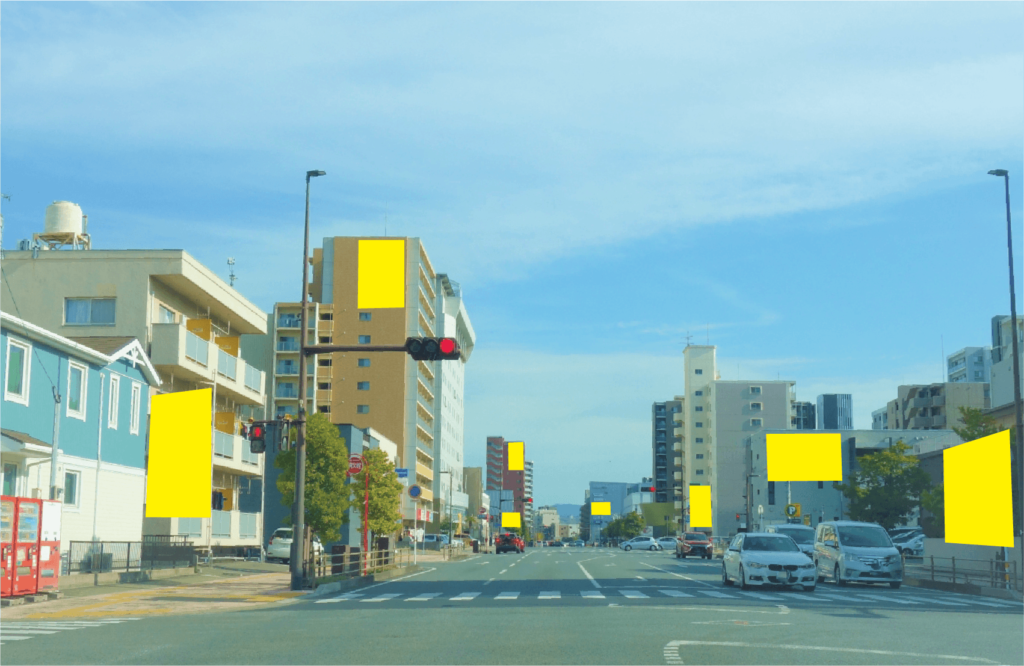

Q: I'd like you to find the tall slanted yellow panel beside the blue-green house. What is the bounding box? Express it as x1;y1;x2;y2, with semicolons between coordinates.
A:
145;388;213;518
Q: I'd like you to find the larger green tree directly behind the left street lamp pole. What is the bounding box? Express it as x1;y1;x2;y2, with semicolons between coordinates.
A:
273;414;349;542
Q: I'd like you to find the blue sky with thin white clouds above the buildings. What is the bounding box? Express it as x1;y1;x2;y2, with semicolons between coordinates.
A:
0;0;1024;503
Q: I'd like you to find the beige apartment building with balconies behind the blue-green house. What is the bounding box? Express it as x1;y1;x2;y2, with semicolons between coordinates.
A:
4;240;267;553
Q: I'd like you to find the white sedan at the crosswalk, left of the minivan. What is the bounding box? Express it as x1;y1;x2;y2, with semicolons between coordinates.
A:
722;533;816;591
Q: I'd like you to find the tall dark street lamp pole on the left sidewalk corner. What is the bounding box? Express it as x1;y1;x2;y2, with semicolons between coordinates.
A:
289;171;327;590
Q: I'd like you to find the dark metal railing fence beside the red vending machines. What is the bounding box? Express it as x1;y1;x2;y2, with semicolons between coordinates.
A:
61;535;193;576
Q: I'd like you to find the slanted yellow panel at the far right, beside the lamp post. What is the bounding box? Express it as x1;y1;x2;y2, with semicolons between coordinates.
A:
942;430;1014;547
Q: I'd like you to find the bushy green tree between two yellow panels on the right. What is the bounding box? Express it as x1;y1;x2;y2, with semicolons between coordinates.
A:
837;440;931;530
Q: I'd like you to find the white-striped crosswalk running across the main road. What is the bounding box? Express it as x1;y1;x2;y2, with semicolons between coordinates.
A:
314;585;1024;611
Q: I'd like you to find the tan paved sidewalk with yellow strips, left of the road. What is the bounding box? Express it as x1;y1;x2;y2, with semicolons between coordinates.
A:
0;561;308;620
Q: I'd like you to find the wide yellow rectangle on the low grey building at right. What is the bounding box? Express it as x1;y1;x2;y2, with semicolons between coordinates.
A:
765;432;843;482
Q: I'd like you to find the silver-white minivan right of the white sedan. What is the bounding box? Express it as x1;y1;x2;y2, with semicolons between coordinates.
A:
814;521;903;589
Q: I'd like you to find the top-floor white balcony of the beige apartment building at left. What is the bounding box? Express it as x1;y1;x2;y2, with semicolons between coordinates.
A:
150;324;265;405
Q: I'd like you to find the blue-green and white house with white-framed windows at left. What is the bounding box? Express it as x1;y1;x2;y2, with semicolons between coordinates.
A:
0;313;161;543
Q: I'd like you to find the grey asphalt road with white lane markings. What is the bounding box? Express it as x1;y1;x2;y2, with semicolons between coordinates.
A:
0;548;1024;666
